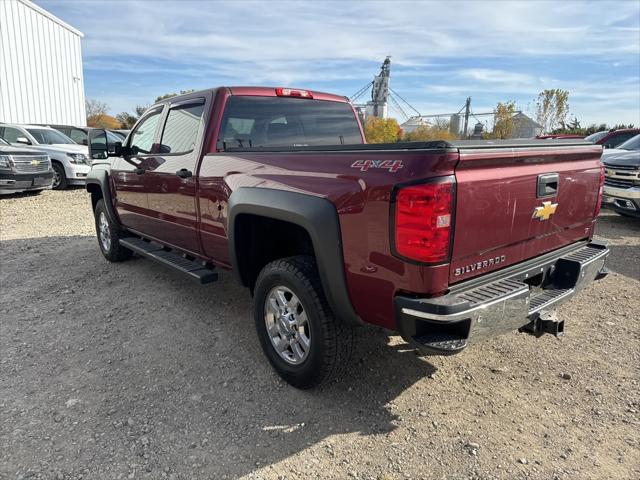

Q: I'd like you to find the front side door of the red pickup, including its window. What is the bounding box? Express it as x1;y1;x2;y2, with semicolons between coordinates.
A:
111;107;163;233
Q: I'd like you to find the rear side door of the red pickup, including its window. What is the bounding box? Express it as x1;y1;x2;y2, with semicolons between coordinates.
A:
144;97;205;254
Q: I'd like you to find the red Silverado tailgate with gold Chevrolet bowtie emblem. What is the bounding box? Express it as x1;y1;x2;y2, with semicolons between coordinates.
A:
449;142;602;283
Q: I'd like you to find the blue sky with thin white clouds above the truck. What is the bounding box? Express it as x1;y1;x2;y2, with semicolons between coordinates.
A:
36;0;640;126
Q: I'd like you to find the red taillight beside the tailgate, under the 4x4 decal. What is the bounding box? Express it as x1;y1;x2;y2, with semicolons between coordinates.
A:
395;178;454;263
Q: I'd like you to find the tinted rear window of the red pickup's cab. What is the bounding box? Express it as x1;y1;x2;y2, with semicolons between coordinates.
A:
218;96;363;149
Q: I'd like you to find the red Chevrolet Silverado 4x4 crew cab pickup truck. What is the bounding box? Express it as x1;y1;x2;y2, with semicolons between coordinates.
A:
87;87;609;388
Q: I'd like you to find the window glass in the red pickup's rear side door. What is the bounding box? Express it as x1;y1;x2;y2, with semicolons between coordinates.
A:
160;101;204;155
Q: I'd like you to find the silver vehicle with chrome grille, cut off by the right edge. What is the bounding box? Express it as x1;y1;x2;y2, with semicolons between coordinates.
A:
602;148;640;217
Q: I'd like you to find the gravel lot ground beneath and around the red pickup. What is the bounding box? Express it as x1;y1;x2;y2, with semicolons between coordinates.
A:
0;190;640;480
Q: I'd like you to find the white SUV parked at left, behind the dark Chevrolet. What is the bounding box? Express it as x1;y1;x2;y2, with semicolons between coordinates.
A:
0;123;91;189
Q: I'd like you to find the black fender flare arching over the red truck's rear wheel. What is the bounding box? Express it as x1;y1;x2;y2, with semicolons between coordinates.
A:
228;187;363;325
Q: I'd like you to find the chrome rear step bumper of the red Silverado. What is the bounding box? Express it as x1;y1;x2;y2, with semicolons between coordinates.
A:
395;242;609;355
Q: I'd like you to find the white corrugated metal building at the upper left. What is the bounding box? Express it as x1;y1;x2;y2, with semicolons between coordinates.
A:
0;0;86;126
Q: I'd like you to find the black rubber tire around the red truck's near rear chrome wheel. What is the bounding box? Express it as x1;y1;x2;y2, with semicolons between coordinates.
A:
253;255;354;389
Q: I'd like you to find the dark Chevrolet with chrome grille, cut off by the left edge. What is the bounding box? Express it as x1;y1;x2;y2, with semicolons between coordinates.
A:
0;138;53;194
